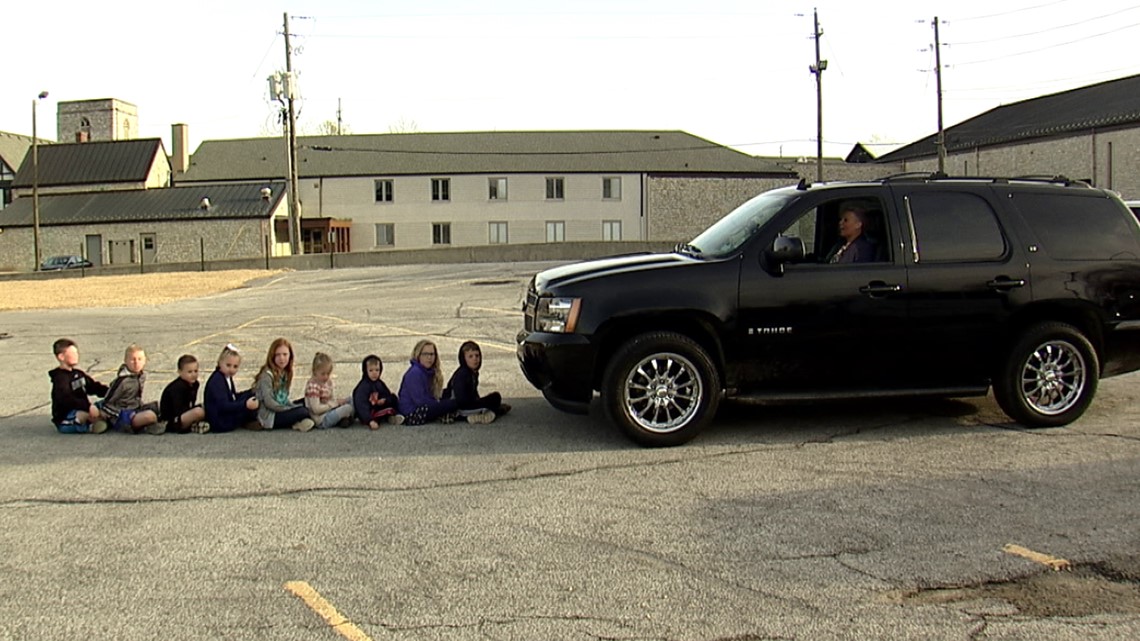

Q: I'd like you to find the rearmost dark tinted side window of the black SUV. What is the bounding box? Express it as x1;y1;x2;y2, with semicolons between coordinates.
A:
1012;194;1138;260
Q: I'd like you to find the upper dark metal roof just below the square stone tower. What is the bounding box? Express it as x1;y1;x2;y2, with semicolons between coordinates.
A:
13;138;166;188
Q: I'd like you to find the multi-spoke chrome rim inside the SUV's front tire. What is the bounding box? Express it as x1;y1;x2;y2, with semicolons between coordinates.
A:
622;354;705;433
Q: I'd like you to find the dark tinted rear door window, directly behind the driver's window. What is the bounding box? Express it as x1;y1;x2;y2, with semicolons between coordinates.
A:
906;192;1005;262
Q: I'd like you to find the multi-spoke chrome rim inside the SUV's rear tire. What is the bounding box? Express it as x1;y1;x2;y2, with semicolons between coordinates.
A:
1020;340;1088;416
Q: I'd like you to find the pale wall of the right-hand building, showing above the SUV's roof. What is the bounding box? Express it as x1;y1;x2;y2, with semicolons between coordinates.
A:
904;128;1140;200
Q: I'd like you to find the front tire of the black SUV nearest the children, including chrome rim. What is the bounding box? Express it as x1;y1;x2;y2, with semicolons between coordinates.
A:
602;332;720;447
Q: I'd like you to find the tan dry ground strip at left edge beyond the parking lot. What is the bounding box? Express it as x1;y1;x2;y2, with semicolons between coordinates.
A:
0;269;279;311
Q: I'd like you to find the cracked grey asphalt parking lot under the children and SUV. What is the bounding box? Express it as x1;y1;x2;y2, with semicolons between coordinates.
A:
0;263;1140;641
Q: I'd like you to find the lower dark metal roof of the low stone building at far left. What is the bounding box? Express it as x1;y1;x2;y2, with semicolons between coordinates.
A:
0;182;285;228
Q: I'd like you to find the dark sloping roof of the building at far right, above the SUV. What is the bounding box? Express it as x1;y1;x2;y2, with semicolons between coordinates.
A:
878;75;1140;162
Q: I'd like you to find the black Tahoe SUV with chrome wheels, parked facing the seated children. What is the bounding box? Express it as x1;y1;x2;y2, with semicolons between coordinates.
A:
518;175;1140;446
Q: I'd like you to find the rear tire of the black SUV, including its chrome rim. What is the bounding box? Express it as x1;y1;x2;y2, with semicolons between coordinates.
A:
994;323;1100;428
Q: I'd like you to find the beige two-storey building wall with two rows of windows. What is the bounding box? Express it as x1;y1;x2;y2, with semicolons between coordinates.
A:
301;173;644;251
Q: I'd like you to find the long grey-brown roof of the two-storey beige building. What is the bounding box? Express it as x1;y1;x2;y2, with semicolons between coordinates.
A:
176;131;793;184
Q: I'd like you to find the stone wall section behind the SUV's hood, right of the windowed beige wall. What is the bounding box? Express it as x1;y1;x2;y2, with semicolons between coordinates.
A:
645;177;797;242
